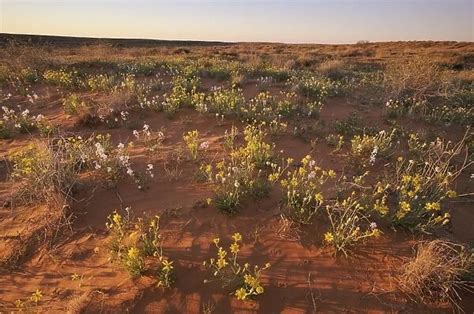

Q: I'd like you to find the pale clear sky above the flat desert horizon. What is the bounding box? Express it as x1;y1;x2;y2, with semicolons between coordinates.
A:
0;0;474;43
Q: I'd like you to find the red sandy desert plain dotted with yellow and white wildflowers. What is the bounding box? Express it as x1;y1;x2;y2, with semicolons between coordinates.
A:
0;38;474;312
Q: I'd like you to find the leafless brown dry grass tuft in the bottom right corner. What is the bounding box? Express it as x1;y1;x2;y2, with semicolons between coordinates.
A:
399;240;474;309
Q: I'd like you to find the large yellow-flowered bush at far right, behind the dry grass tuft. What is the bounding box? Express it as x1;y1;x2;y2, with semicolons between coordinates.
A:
389;139;472;232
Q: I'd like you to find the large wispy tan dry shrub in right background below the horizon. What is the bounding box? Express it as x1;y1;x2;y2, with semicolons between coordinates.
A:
384;56;443;98
